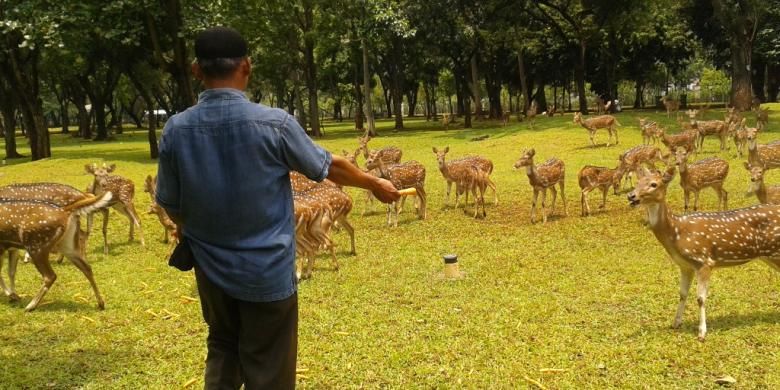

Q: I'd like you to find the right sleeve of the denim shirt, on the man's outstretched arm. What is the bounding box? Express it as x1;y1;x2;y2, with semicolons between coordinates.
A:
279;115;333;181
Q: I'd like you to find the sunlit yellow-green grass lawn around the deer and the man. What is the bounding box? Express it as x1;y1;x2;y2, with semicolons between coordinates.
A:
0;107;780;389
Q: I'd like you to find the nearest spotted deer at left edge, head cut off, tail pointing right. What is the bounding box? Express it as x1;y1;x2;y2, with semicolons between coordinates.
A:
0;192;112;311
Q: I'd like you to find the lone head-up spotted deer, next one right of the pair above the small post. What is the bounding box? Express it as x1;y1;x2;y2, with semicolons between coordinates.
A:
514;149;568;223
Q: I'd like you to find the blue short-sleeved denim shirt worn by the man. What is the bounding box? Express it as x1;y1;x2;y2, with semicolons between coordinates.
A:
156;89;332;302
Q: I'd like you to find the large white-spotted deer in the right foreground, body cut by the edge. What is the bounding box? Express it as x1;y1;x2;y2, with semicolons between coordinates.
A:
628;167;780;341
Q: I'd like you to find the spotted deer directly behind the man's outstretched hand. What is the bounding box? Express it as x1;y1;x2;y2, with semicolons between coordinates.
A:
366;150;427;227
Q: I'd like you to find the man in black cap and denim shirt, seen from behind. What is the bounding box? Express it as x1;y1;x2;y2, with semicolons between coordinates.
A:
157;27;399;389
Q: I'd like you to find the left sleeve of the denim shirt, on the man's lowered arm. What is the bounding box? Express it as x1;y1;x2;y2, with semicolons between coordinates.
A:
155;121;181;214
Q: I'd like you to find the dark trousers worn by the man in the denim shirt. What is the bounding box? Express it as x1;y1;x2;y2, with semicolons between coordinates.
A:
195;267;298;390
